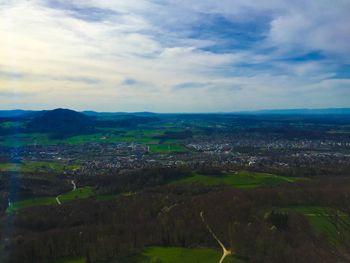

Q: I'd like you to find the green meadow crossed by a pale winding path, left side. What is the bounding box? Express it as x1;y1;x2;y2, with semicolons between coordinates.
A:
6;186;94;213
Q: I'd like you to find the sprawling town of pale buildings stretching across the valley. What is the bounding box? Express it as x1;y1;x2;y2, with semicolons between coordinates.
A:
0;137;350;174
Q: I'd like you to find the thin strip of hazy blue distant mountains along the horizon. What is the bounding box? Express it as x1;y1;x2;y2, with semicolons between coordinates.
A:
0;108;350;118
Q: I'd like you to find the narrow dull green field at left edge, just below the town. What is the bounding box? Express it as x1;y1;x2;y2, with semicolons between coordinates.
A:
0;161;79;173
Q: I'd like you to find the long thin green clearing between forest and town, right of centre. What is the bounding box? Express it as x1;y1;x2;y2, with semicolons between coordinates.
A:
173;171;305;188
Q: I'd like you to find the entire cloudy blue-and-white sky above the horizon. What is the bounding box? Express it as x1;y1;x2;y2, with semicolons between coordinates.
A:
0;0;350;112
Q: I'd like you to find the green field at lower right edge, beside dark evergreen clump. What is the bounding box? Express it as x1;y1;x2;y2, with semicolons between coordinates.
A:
279;206;350;243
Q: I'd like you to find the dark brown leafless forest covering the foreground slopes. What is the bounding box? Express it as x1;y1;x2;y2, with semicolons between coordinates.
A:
1;168;350;263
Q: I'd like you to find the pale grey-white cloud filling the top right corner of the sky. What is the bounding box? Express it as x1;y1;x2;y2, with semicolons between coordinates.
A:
269;0;350;59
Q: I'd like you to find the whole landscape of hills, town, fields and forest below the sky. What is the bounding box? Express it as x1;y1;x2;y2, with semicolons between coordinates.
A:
0;109;350;263
